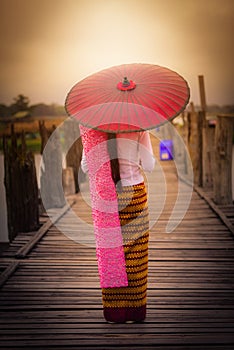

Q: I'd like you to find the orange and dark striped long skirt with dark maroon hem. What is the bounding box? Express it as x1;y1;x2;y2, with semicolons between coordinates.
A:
102;183;149;323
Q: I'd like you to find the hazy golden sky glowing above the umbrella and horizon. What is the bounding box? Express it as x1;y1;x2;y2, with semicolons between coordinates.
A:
0;0;234;105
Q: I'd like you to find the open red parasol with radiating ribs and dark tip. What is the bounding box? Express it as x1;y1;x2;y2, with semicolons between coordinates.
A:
65;63;189;133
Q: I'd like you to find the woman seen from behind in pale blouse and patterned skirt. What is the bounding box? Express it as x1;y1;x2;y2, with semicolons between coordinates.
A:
81;131;155;323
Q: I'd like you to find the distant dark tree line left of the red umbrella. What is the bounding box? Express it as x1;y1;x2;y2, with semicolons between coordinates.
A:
0;94;66;118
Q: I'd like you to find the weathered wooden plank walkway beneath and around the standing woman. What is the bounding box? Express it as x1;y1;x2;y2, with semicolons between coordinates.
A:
0;152;234;350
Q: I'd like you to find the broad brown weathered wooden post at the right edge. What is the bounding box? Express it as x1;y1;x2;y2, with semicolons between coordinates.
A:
214;115;234;204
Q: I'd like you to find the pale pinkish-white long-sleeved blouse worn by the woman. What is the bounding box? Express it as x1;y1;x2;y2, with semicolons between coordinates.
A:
81;131;155;186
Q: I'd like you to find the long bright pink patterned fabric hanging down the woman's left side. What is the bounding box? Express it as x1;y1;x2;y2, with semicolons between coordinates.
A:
80;126;128;288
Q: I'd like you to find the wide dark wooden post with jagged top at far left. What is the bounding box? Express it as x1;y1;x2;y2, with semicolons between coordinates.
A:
4;126;39;241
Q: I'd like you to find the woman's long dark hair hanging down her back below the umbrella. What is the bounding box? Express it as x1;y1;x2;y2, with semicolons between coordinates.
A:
107;133;121;188
